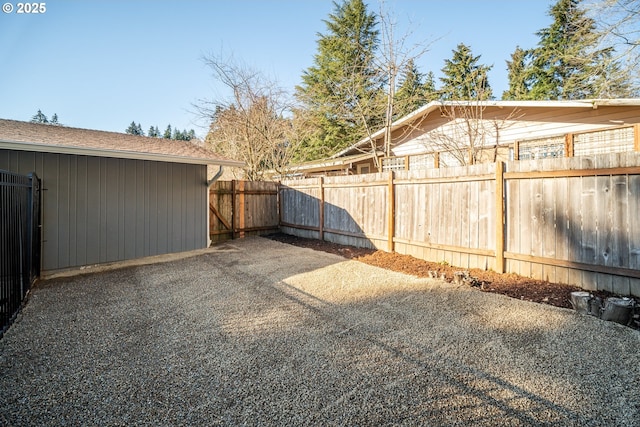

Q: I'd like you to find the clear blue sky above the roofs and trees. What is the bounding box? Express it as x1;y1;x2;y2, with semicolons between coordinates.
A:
0;0;555;136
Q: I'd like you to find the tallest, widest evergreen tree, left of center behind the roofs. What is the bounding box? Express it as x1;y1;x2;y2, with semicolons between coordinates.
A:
296;0;384;159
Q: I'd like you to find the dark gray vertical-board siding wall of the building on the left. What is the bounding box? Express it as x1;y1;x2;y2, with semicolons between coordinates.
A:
0;150;208;271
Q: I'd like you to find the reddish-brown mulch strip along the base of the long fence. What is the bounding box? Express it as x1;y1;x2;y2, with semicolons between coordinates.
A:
265;233;640;308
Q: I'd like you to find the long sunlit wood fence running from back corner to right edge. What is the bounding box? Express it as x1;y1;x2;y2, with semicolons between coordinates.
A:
279;153;640;296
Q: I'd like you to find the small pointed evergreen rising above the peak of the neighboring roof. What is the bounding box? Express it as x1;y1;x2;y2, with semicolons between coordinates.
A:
440;43;492;101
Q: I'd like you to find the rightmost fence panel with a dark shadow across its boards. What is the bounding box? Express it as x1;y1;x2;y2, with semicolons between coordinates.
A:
505;153;640;295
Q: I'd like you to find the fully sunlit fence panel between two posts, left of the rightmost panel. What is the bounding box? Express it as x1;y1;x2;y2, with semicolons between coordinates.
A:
394;164;496;268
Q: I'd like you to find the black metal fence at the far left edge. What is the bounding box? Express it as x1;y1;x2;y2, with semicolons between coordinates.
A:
0;170;40;337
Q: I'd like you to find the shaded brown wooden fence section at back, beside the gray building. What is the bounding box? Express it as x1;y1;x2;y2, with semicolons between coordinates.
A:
209;180;279;242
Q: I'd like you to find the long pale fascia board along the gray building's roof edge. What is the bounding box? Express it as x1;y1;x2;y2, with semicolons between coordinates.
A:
0;140;245;167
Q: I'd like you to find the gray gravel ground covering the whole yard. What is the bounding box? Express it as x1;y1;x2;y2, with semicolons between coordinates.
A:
0;238;640;426
